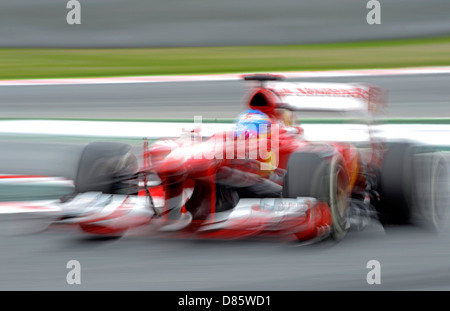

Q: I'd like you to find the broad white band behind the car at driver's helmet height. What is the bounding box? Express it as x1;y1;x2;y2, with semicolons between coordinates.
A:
0;120;450;146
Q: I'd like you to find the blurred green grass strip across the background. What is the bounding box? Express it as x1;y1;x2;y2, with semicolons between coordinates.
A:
0;37;450;79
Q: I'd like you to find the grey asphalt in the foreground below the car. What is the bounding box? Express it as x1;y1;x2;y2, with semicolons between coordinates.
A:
0;225;450;291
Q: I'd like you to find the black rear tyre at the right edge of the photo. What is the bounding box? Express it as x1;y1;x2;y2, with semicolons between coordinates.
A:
378;143;448;231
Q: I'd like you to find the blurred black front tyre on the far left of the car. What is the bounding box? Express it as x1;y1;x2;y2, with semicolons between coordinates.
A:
75;142;138;194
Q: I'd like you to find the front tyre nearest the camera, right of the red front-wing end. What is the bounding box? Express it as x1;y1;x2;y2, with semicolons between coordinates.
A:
283;153;350;240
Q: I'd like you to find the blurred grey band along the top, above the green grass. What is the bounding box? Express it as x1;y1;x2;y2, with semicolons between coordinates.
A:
0;0;450;47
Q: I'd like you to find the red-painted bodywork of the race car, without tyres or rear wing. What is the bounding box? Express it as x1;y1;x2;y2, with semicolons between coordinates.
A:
127;83;381;239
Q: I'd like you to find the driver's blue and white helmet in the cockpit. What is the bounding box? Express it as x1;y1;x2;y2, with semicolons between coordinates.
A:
235;109;271;138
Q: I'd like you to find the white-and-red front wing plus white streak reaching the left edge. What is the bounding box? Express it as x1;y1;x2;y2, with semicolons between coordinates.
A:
0;192;332;240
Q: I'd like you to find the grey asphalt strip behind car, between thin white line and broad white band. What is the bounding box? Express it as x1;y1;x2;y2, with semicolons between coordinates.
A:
0;74;450;119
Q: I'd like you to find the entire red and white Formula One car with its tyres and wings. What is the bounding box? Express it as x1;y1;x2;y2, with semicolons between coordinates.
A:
2;75;448;241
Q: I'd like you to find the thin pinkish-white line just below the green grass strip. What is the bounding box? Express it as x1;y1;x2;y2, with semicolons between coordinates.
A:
0;66;450;86
